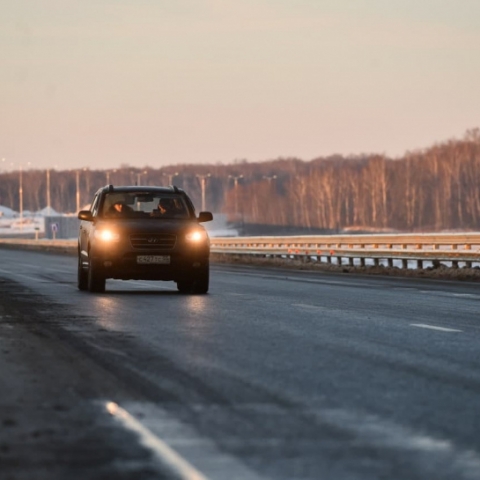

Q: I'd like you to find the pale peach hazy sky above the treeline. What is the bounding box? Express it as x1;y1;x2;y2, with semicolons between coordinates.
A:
0;0;480;172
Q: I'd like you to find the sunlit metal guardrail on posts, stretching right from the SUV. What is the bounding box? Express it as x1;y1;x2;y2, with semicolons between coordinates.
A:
211;233;480;268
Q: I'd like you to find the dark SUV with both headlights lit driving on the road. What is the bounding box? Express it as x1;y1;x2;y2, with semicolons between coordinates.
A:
78;185;213;293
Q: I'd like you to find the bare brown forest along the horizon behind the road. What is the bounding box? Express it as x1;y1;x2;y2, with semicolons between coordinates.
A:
0;128;480;232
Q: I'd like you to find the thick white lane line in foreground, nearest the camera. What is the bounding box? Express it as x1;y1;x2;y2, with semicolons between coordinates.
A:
105;402;208;480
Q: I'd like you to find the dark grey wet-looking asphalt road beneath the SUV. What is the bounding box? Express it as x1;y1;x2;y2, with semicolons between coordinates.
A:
0;249;480;480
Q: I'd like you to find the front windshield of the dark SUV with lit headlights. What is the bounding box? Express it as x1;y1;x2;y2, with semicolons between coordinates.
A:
102;192;189;219
